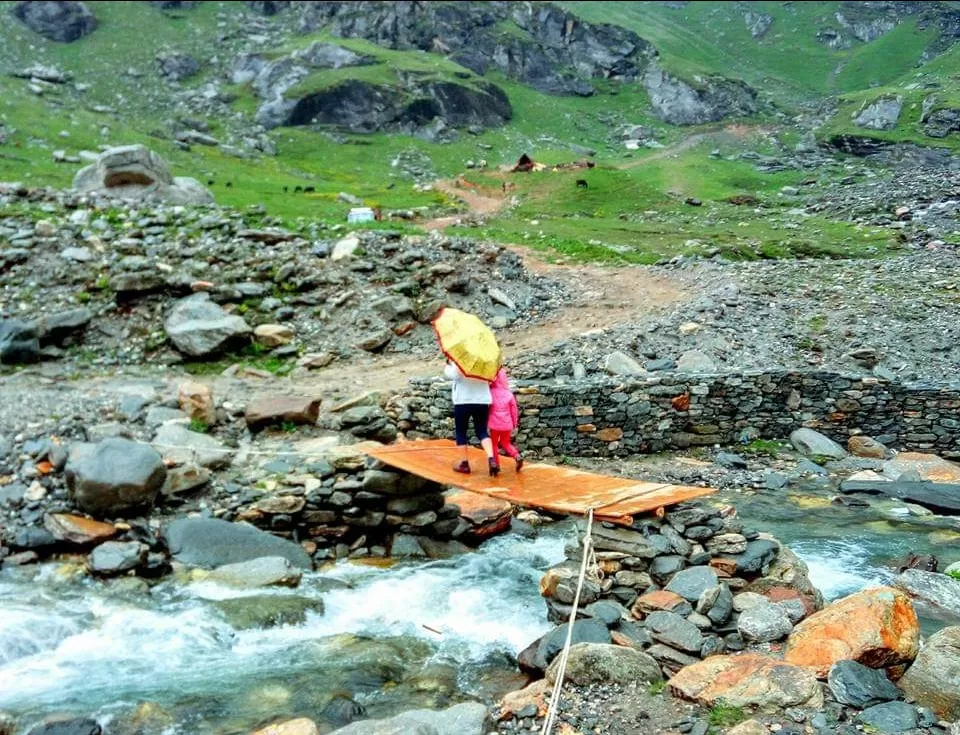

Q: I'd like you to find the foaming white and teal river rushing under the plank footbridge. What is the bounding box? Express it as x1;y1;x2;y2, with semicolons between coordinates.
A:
0;503;948;735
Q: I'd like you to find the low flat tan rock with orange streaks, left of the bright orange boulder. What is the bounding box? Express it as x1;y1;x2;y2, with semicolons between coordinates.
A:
667;653;823;709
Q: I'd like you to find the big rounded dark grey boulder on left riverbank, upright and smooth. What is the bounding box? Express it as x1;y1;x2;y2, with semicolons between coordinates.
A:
65;438;167;518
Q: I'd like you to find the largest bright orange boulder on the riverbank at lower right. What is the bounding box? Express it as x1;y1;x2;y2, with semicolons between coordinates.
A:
785;587;920;678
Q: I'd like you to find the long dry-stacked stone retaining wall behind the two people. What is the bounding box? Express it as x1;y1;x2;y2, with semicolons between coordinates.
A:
388;370;960;458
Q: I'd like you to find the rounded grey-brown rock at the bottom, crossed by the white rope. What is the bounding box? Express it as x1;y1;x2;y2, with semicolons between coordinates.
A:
546;643;663;686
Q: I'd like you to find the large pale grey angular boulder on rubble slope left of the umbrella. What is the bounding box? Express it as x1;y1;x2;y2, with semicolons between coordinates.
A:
163;293;250;357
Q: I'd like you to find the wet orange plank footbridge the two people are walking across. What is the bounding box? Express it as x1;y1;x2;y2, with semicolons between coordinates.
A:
360;439;716;525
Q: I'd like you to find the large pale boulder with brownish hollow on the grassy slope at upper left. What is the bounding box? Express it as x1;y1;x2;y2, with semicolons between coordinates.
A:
73;144;214;204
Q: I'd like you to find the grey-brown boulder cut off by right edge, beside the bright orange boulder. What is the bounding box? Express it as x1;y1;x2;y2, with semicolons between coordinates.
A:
899;627;960;721
